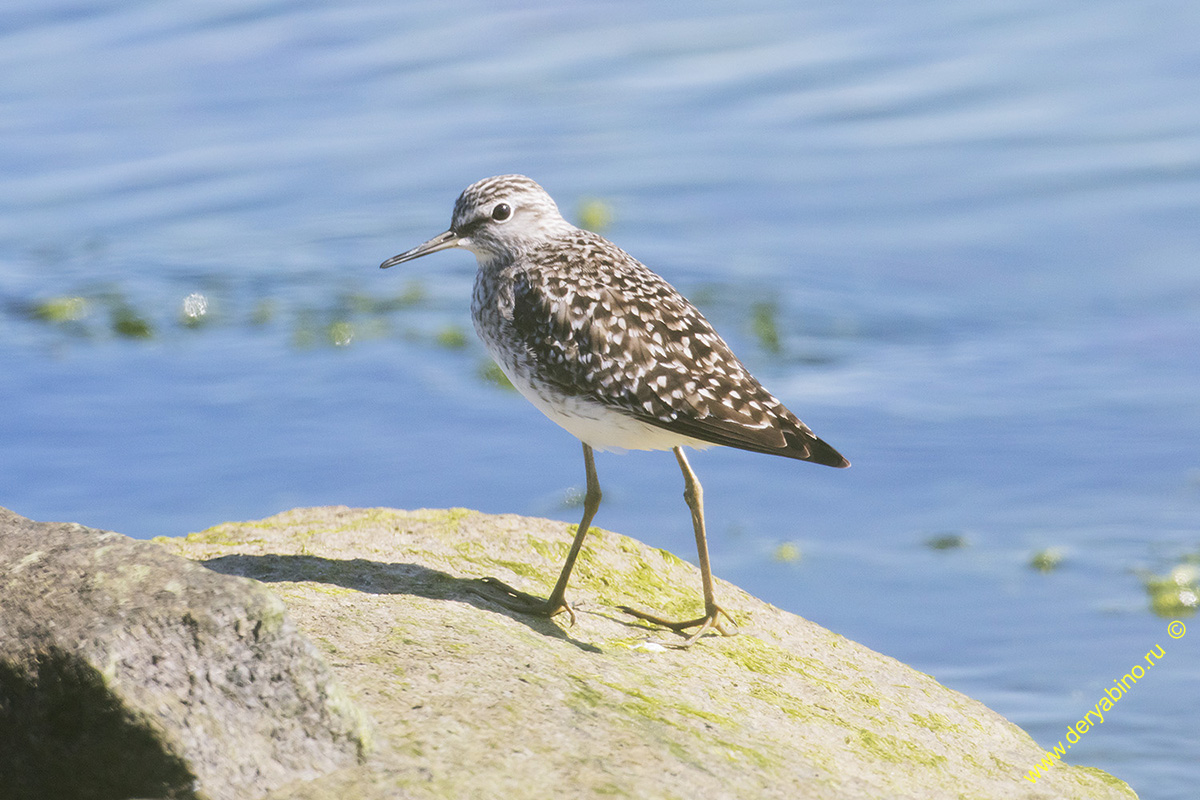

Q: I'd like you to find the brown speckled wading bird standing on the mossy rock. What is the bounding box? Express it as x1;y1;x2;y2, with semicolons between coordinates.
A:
379;175;850;648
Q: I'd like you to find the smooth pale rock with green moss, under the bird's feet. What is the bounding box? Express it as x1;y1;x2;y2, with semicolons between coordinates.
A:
160;509;1134;800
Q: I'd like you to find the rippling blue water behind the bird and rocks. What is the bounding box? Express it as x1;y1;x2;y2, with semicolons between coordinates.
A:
0;0;1200;800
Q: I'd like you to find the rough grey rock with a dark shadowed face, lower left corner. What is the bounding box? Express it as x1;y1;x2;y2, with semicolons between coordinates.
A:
0;509;367;800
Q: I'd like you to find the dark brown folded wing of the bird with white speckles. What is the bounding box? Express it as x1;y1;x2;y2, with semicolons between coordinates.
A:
512;230;850;467
